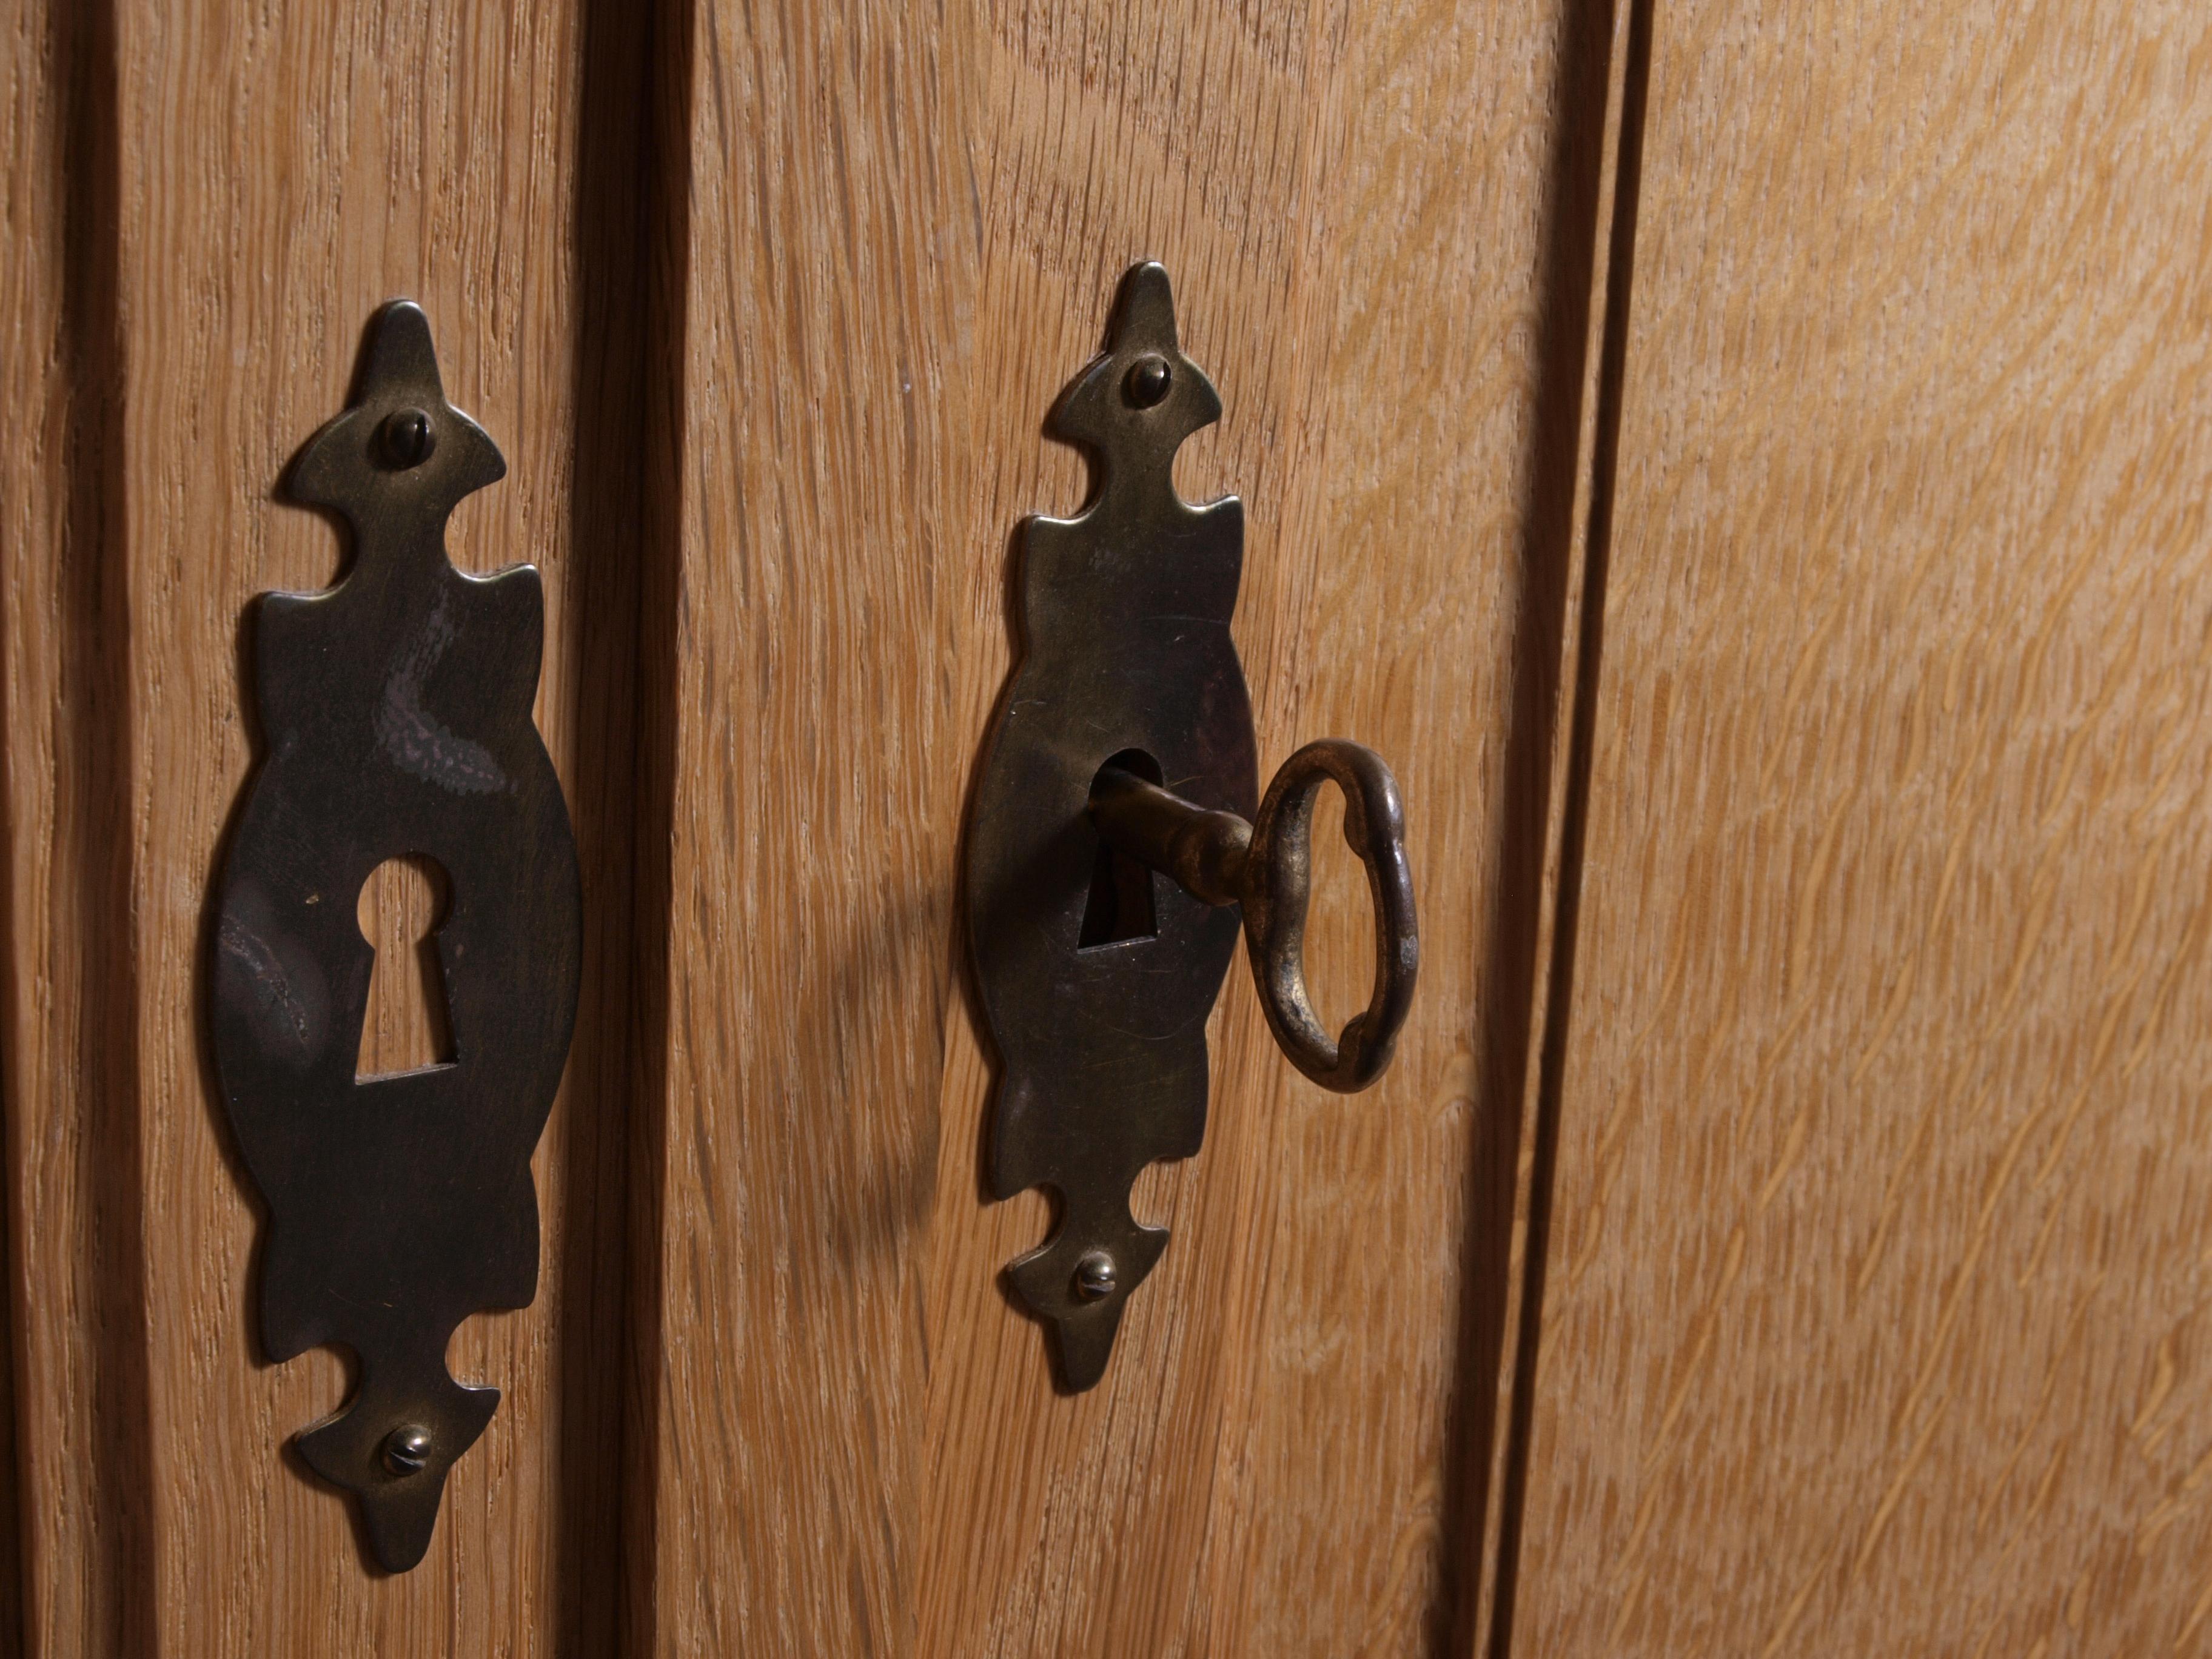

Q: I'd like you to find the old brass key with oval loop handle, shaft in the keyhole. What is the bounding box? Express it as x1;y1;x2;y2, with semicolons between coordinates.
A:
1090;737;1420;1095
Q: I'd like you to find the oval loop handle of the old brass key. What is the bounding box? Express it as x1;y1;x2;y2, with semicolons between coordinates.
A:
1243;737;1420;1095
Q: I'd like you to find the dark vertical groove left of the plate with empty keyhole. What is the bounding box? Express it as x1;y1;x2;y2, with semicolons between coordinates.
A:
7;0;159;1655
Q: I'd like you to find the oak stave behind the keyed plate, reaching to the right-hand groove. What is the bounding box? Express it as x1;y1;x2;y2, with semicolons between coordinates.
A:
922;4;1604;1655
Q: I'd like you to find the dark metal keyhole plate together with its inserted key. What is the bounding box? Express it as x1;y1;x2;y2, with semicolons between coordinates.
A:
967;263;1420;1389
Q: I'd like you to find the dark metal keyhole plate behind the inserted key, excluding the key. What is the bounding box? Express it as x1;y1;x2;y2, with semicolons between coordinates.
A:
967;263;1259;1389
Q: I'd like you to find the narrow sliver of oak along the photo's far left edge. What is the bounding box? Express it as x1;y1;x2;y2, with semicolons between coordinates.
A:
0;4;109;1652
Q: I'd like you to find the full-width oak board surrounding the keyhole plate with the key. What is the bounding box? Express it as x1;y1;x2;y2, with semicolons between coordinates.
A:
632;0;1606;1657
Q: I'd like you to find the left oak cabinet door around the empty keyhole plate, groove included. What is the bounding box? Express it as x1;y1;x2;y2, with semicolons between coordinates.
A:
7;2;654;1655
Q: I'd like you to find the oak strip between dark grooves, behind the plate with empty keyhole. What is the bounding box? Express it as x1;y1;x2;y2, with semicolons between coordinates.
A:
130;4;592;1652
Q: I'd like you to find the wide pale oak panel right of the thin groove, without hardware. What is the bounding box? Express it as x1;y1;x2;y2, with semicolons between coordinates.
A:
1515;0;2212;1657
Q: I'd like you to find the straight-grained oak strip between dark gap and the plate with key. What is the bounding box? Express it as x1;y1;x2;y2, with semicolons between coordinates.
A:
626;0;971;1655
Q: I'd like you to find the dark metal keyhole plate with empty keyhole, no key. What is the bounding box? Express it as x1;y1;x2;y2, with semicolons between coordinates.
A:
212;301;581;1573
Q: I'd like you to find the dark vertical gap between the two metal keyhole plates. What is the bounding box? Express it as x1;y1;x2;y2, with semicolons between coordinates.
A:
549;0;682;1659
